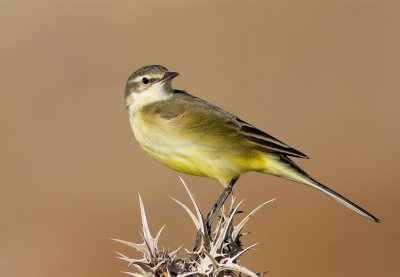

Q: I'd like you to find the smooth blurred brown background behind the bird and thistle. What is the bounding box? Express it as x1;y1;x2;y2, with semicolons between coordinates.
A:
0;1;400;277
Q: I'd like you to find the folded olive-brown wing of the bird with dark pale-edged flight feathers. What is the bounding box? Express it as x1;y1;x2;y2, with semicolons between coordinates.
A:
143;90;308;158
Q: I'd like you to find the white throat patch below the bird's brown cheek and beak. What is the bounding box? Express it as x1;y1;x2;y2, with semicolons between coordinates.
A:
126;81;173;114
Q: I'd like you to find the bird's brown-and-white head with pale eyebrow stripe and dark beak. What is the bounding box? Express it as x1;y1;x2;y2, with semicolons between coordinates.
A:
125;65;179;109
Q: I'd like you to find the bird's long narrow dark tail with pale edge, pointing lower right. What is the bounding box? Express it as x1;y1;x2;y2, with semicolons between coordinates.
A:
266;155;380;222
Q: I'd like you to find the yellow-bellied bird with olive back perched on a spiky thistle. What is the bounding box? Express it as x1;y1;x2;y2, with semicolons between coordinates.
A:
125;65;379;224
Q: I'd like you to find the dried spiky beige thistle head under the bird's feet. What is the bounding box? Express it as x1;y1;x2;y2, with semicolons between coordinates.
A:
114;179;274;277
